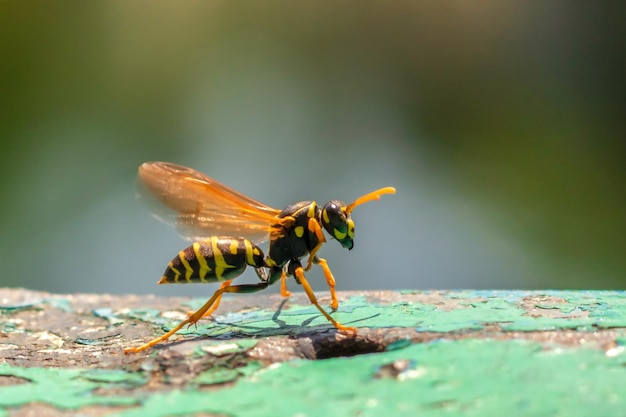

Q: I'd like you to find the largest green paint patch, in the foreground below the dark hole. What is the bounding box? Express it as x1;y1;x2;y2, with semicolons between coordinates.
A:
109;339;626;417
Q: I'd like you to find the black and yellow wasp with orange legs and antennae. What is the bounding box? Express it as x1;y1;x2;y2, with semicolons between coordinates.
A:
124;162;396;353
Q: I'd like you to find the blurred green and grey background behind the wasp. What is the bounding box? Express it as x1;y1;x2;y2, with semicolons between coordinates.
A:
0;1;626;295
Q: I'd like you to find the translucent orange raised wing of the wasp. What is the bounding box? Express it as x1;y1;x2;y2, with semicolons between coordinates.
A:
139;162;281;243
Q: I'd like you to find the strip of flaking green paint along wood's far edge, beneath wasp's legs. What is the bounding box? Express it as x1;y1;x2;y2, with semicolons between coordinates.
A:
130;290;626;337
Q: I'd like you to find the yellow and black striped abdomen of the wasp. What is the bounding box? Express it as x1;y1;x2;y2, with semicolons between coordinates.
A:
159;236;265;284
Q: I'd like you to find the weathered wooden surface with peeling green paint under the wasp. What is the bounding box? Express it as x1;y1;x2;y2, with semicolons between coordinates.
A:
0;289;626;417
